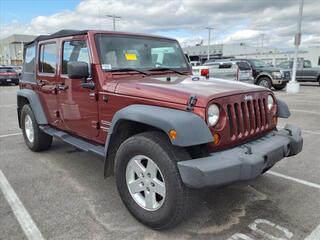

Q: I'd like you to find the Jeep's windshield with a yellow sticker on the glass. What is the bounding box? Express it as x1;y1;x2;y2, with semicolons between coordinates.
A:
96;34;188;71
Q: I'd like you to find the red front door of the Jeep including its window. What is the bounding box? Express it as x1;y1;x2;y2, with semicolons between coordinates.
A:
57;37;98;139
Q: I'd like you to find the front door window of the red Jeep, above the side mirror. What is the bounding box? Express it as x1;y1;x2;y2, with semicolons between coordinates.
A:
61;40;90;74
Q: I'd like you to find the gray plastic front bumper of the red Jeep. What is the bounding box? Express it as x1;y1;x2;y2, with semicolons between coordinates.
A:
178;125;303;188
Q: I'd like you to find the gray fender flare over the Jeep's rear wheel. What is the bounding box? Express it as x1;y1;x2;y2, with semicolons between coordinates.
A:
17;89;48;125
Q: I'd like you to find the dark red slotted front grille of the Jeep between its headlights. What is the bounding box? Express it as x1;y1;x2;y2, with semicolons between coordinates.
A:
226;98;270;141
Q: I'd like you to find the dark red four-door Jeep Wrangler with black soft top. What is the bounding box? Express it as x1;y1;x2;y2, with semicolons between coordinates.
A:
17;30;303;229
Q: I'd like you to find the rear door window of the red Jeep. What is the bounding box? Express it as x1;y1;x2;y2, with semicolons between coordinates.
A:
39;43;57;73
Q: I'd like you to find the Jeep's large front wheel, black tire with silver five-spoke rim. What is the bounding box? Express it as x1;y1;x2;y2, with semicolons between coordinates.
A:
115;132;197;229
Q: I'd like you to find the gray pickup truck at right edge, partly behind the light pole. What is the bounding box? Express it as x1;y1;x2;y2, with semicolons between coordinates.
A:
278;59;320;85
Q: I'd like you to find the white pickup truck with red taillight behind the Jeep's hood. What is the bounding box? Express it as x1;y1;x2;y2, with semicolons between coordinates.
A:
192;61;253;84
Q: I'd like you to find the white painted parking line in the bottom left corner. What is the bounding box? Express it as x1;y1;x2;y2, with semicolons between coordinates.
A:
0;170;44;240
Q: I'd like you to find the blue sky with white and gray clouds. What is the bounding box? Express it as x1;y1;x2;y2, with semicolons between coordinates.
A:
0;0;320;48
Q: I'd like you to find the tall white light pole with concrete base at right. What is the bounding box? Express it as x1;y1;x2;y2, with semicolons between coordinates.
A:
287;0;304;93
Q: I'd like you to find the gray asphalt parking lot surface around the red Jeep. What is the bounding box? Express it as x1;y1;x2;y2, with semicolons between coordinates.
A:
0;84;320;240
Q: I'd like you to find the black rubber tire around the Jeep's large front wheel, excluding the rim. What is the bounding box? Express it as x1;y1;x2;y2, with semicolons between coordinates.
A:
115;131;198;230
